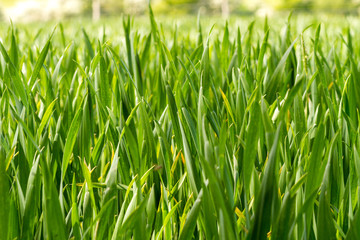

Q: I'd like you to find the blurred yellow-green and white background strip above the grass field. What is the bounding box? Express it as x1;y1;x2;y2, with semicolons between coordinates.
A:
0;0;360;22
